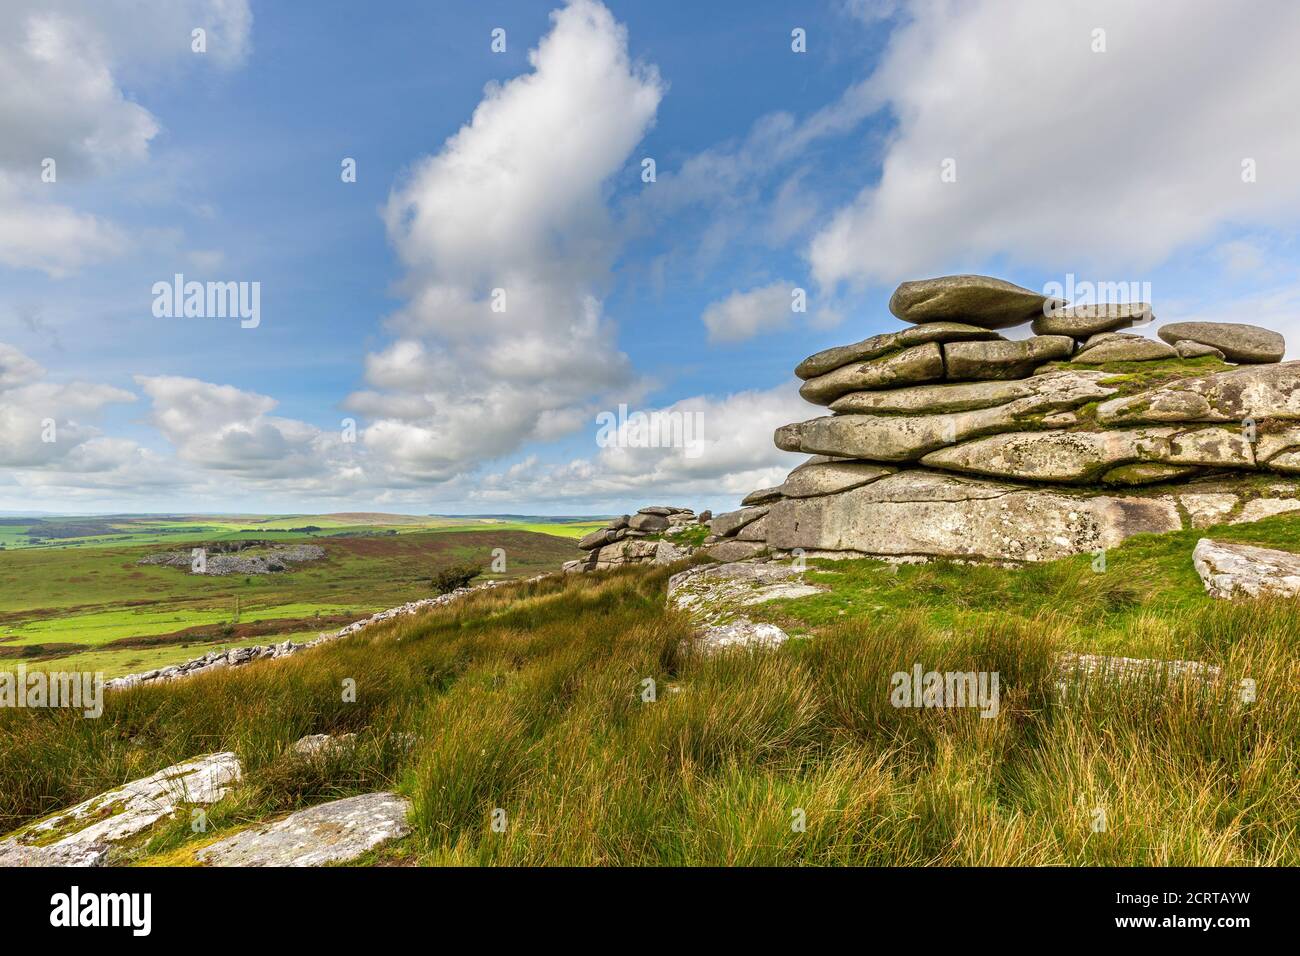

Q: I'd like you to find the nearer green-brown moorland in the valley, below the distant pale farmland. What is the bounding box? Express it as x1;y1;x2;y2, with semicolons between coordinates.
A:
0;528;579;676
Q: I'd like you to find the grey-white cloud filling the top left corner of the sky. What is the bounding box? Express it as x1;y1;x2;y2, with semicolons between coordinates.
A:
0;0;252;277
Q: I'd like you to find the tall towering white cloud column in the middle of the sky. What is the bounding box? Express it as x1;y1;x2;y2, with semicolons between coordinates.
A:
348;0;663;480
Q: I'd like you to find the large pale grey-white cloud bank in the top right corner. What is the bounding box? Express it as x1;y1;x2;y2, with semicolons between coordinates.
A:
809;0;1300;285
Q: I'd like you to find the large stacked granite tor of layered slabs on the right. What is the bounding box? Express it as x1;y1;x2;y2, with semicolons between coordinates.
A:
706;276;1300;561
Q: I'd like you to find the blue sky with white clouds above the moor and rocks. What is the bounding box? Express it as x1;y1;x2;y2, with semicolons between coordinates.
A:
0;0;1300;514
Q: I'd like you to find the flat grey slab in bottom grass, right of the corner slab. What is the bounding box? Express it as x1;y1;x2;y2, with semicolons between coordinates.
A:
195;792;411;866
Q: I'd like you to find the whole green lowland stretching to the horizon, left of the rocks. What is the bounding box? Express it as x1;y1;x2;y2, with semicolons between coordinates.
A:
0;515;601;676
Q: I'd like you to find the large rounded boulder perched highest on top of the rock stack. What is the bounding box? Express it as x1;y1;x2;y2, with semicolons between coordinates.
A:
889;276;1060;329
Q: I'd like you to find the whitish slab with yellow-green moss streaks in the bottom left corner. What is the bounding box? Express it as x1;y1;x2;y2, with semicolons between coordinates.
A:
0;752;242;866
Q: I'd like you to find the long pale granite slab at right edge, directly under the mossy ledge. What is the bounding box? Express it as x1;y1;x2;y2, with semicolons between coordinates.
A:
1097;362;1300;425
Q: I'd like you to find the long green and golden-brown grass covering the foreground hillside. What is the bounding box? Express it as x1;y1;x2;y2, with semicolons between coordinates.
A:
0;518;1300;865
